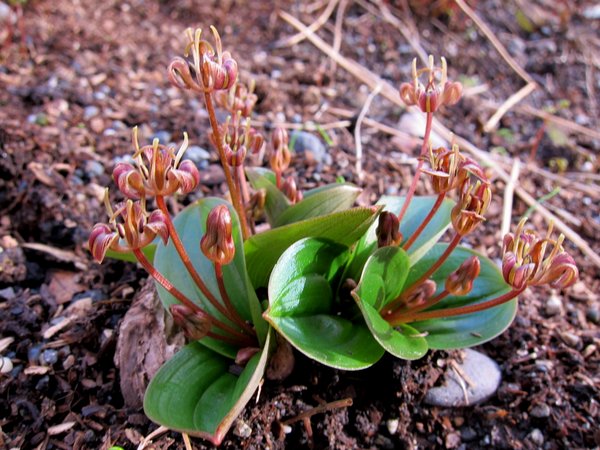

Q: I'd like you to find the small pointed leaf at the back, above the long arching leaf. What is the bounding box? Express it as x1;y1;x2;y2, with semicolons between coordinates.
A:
274;183;361;227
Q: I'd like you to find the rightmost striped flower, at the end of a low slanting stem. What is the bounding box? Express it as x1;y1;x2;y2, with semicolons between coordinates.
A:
502;218;579;290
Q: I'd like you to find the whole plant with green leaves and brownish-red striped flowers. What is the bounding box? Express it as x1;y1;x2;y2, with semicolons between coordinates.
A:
89;28;578;444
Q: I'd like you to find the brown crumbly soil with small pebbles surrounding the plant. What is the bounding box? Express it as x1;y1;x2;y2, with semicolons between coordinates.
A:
0;0;600;449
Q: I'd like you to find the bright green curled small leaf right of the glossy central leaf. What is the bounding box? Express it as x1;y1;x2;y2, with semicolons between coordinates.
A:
352;247;428;359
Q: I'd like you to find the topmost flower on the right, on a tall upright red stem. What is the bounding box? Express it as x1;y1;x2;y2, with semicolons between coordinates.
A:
400;55;462;113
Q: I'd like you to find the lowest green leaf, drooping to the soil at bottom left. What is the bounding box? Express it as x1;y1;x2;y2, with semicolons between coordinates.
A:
144;333;270;445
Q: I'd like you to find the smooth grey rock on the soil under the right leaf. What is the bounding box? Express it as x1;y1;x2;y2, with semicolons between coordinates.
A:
425;349;501;407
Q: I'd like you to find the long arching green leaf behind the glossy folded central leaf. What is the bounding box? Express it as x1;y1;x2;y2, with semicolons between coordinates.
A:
244;208;380;288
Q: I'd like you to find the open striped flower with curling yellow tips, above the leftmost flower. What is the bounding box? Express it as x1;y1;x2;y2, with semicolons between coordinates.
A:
113;127;200;199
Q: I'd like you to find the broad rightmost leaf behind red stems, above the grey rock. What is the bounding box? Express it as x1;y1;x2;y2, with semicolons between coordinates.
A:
405;244;517;349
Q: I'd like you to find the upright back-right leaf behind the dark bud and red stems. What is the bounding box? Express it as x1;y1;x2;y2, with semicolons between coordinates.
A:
347;196;455;279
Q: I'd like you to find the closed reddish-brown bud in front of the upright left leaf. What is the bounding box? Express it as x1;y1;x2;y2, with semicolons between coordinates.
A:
200;205;235;265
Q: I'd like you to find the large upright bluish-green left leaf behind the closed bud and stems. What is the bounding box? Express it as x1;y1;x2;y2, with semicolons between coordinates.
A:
154;197;267;357
